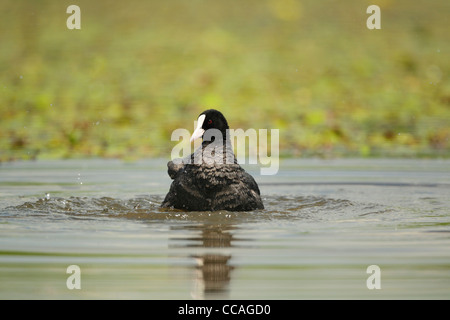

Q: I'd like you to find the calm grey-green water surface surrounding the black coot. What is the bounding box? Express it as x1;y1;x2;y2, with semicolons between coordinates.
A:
0;159;450;299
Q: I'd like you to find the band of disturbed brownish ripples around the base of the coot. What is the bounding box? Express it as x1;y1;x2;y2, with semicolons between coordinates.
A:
6;195;389;221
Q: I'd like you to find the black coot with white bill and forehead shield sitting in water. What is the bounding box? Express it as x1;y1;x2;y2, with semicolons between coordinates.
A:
161;109;264;211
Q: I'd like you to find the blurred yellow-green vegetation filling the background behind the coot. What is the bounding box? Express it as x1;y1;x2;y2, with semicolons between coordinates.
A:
0;0;450;161
